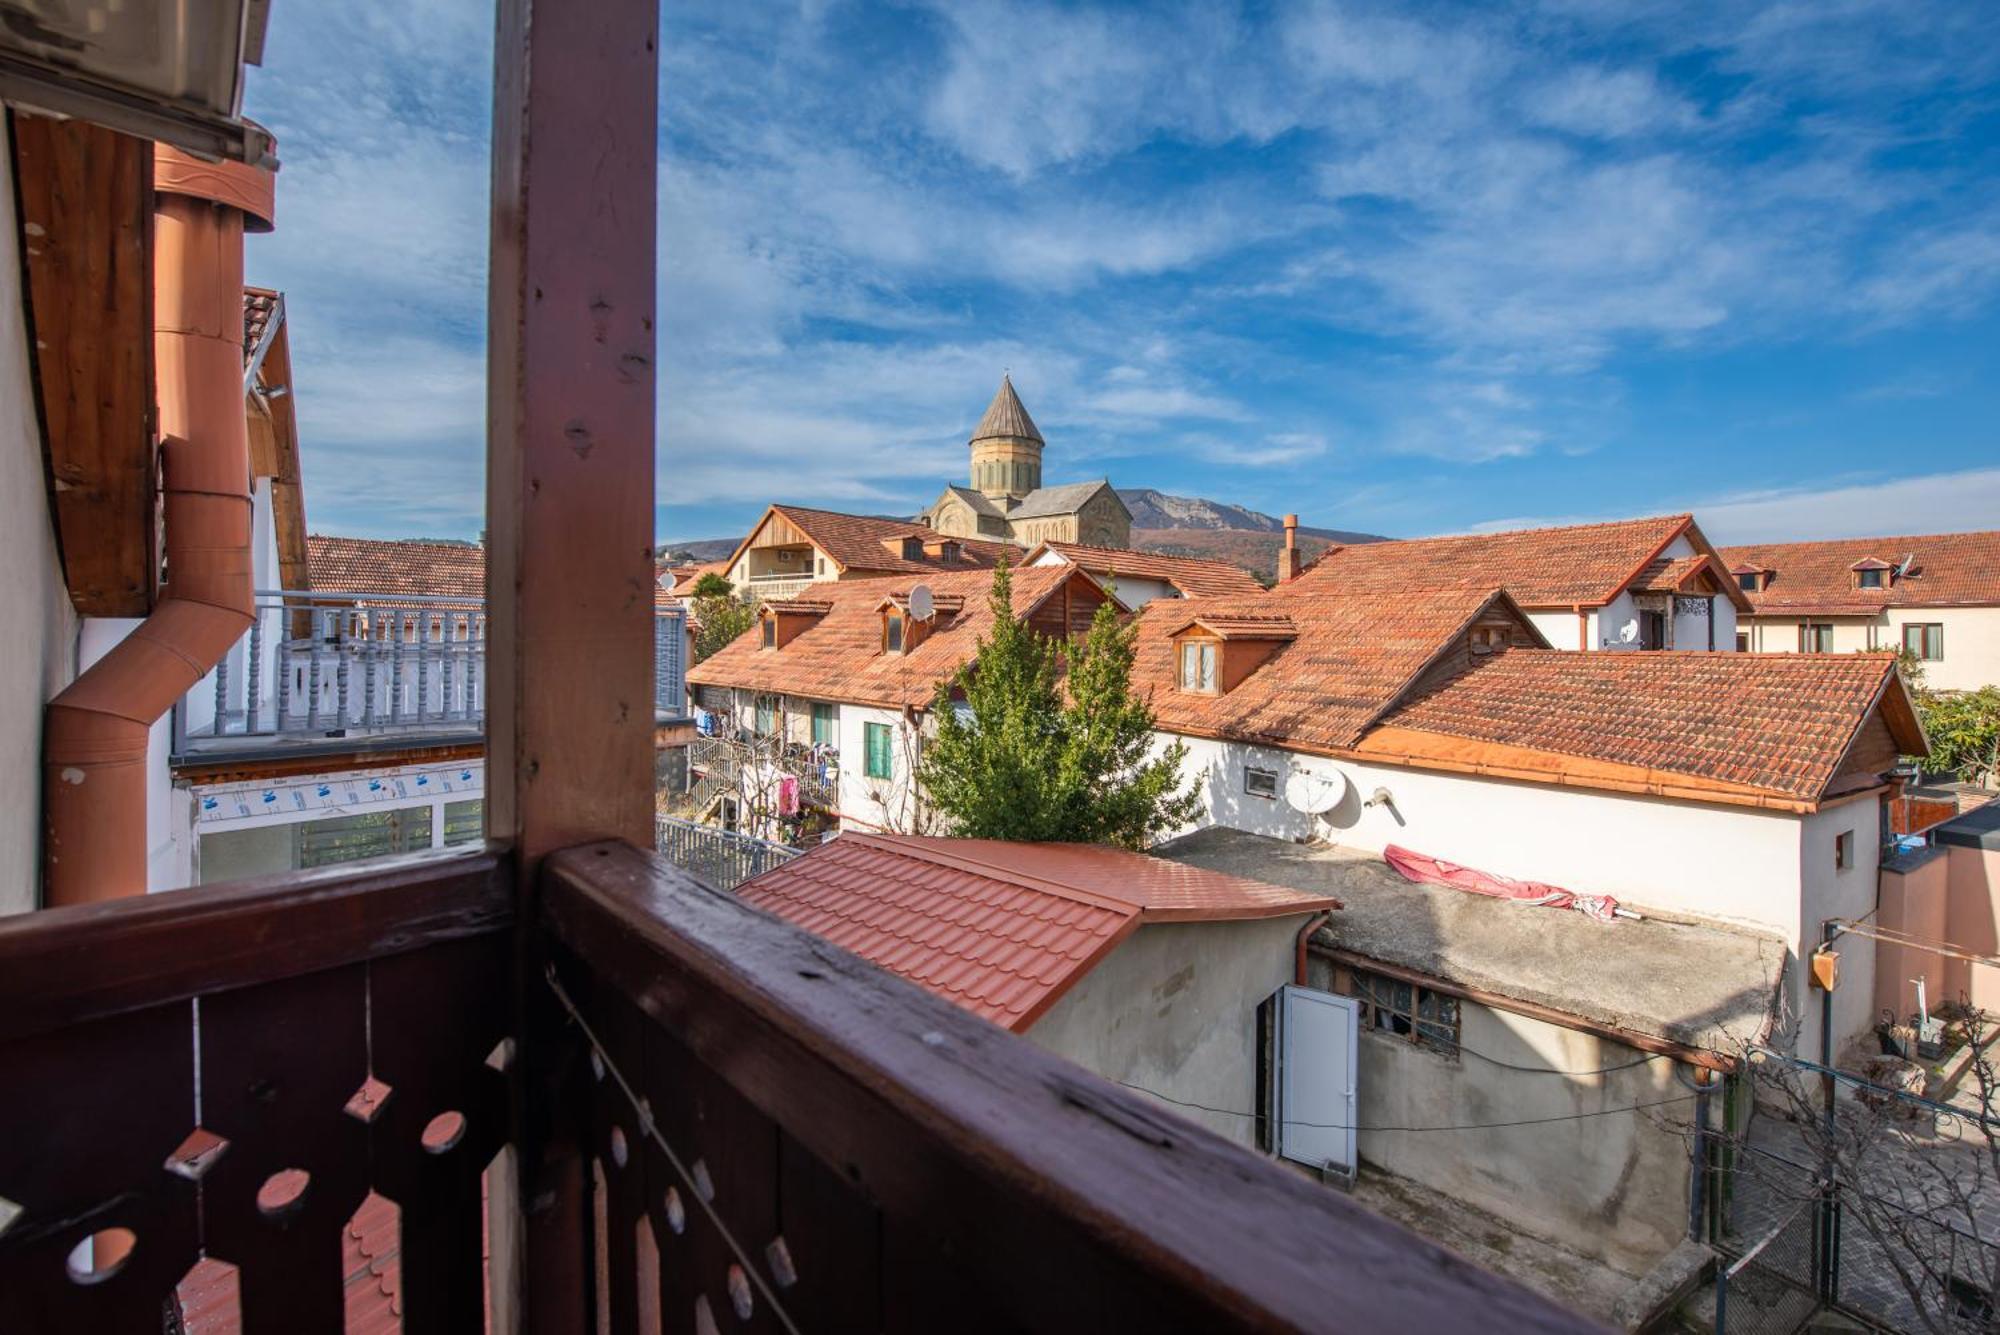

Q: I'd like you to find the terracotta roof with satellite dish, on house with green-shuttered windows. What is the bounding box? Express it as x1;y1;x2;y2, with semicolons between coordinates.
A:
688;566;1096;707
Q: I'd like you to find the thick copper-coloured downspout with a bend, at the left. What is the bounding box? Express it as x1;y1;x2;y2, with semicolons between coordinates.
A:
42;146;272;907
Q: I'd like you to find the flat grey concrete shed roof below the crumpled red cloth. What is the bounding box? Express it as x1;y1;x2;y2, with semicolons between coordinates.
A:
1152;827;1786;1055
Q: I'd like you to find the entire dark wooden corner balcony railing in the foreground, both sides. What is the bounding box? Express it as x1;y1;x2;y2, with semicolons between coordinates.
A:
0;843;1584;1335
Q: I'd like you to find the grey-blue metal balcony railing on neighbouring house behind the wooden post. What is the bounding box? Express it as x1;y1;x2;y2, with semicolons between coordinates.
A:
174;590;688;751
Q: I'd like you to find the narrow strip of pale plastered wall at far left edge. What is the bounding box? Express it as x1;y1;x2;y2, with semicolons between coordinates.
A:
0;154;76;913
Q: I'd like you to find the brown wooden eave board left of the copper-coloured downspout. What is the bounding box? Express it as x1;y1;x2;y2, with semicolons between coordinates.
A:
10;112;158;618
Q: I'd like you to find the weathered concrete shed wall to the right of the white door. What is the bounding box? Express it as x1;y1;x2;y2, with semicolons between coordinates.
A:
1328;979;1688;1275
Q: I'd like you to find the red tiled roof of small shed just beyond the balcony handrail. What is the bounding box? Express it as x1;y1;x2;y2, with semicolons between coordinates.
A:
736;833;1338;1033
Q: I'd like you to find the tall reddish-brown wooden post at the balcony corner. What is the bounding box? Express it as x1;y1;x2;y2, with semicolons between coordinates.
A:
486;0;660;1331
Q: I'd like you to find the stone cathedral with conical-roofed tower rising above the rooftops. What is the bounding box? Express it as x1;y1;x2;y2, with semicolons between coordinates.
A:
918;376;1132;548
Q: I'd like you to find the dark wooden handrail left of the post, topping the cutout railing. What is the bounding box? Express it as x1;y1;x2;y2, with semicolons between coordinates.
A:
0;849;514;1041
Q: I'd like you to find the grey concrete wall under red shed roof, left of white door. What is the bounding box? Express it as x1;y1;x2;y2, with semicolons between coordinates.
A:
1028;915;1306;1145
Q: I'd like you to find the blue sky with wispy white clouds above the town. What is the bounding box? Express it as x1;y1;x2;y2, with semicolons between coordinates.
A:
248;0;2000;542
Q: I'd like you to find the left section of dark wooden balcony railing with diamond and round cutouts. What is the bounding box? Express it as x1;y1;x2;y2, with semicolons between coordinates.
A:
0;853;514;1335
